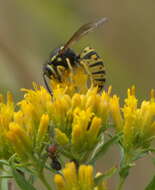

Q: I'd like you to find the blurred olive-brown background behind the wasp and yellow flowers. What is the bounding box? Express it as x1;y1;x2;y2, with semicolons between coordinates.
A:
0;0;155;190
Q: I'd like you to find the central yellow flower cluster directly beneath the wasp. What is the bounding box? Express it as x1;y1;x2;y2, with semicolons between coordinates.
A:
49;86;111;159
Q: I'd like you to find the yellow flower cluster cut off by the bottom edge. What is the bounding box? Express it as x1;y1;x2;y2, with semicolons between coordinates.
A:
54;162;107;190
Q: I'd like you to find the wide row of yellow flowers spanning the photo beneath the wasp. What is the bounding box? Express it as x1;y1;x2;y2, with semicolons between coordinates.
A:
0;72;155;164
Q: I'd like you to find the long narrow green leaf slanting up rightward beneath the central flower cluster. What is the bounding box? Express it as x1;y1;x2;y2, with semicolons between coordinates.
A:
88;132;122;164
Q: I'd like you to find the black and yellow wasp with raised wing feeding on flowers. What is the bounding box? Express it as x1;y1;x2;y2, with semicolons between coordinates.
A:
43;17;108;95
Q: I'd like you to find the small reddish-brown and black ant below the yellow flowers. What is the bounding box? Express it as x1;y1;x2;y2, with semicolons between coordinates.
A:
47;144;61;170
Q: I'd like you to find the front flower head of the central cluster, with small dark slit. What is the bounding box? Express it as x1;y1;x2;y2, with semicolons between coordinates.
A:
53;107;102;159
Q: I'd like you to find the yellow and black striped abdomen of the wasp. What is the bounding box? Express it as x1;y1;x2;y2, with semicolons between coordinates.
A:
80;47;106;89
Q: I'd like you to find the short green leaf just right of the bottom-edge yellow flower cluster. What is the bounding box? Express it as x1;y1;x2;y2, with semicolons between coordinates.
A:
94;167;117;185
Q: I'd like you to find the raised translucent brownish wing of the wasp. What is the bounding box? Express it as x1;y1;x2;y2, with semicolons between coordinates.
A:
59;17;108;54
